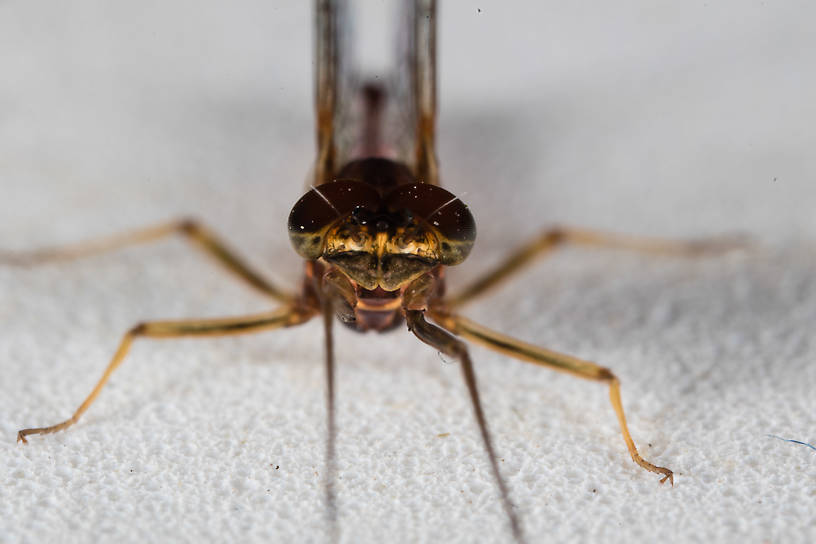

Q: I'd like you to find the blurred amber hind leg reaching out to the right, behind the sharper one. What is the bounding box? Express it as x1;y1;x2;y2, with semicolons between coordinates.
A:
445;228;750;308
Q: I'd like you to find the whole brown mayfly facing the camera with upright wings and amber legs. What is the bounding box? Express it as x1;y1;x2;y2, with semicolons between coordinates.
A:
0;0;722;541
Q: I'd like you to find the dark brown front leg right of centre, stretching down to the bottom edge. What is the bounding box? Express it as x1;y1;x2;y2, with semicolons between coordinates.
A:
405;310;524;542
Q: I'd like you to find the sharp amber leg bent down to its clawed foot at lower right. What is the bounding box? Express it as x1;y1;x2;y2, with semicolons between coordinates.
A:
430;312;674;485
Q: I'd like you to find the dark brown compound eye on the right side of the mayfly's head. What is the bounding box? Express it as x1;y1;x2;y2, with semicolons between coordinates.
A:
386;183;476;266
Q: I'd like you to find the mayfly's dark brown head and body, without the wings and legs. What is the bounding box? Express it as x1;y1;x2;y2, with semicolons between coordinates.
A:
289;76;476;332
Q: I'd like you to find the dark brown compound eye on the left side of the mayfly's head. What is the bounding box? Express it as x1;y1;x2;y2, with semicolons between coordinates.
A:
289;180;380;259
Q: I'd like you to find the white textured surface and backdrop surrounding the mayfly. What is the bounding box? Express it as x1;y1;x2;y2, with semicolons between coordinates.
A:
0;1;816;543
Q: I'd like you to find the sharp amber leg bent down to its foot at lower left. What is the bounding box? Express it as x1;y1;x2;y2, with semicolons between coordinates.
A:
17;307;314;443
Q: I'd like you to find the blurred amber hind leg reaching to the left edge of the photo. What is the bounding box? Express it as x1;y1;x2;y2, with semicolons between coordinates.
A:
0;219;292;303
